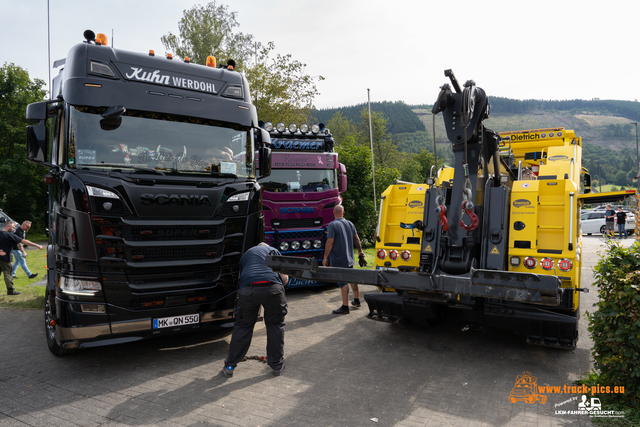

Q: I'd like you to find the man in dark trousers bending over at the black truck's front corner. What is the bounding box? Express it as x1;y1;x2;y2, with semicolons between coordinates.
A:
222;243;289;377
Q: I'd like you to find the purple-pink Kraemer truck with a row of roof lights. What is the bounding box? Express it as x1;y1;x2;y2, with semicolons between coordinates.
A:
260;122;347;288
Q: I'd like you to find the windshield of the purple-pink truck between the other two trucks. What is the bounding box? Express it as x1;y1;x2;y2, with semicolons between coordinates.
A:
260;169;338;192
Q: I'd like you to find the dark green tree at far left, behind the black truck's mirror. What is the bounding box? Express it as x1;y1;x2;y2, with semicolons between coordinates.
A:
0;63;46;230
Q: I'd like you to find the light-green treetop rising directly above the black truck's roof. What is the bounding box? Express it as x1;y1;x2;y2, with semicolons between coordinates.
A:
161;1;255;70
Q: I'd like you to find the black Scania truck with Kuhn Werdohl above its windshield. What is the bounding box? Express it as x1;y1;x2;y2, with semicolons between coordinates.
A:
26;31;271;355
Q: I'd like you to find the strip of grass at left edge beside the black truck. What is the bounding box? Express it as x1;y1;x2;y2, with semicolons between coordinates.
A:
0;242;47;309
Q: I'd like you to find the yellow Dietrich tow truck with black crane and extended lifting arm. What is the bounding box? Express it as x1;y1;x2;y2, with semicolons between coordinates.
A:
267;70;587;348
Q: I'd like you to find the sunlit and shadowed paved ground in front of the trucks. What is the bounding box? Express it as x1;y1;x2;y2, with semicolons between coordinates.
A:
0;236;633;427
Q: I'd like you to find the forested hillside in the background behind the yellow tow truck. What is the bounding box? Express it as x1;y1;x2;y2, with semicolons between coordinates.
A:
314;97;640;191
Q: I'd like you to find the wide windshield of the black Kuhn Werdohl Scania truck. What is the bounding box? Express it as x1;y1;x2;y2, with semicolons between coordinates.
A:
67;107;254;177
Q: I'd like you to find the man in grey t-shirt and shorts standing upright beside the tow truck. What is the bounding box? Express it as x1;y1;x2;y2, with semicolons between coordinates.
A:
323;205;364;314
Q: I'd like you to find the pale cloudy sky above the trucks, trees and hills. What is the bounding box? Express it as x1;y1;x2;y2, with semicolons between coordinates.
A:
0;0;640;108
